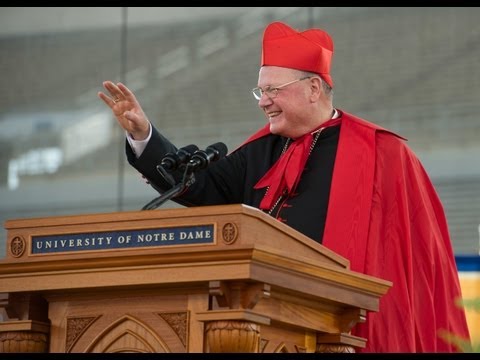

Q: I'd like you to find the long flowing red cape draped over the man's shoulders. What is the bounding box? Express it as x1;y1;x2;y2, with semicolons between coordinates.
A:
240;112;469;352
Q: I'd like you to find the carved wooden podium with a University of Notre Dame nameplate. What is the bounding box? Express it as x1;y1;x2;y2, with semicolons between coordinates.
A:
0;204;391;353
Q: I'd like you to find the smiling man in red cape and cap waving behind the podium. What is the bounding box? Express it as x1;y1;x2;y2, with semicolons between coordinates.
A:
99;22;469;352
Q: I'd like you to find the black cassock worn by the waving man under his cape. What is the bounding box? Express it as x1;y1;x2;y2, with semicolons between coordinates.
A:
126;125;340;243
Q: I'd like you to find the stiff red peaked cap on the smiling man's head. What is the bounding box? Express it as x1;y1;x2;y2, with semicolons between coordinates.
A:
261;21;333;88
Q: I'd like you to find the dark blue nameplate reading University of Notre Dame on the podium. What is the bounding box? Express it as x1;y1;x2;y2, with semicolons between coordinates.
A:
32;225;215;254
